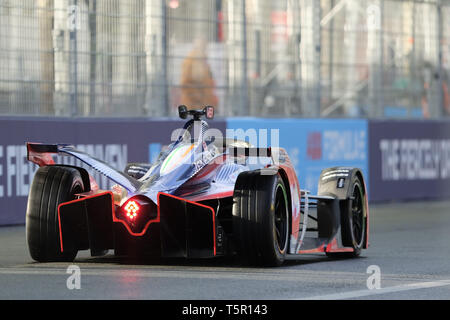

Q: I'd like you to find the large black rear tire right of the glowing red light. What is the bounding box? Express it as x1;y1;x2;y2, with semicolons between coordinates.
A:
233;171;290;267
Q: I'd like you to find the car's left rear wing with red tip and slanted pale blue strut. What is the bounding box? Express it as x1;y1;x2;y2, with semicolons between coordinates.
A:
26;142;142;192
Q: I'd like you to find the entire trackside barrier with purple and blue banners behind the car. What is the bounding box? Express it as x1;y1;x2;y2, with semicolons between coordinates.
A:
0;117;450;225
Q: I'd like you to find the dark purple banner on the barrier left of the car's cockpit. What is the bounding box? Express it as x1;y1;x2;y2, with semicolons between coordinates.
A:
0;118;225;225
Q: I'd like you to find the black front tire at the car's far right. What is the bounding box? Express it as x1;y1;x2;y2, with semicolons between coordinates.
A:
328;175;367;258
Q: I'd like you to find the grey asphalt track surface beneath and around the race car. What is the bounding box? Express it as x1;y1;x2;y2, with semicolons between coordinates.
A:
0;201;450;300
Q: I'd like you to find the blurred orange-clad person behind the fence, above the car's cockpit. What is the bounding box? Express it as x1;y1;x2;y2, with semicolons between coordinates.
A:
180;38;218;109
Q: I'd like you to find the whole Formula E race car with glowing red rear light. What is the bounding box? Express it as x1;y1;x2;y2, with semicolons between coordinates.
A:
26;106;369;266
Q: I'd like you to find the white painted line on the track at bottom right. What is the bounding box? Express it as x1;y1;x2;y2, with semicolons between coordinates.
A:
299;280;450;300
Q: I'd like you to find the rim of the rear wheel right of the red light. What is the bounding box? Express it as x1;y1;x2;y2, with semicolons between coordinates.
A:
274;184;288;253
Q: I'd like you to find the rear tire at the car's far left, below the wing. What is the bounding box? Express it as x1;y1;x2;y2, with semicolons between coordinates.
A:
26;166;84;262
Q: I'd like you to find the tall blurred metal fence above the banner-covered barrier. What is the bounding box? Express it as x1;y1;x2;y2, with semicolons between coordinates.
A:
0;0;450;118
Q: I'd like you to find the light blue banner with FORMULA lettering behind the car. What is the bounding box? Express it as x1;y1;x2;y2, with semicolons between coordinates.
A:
227;118;369;193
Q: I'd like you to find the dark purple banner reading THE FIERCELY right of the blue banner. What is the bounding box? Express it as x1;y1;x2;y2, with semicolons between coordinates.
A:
369;120;450;201
